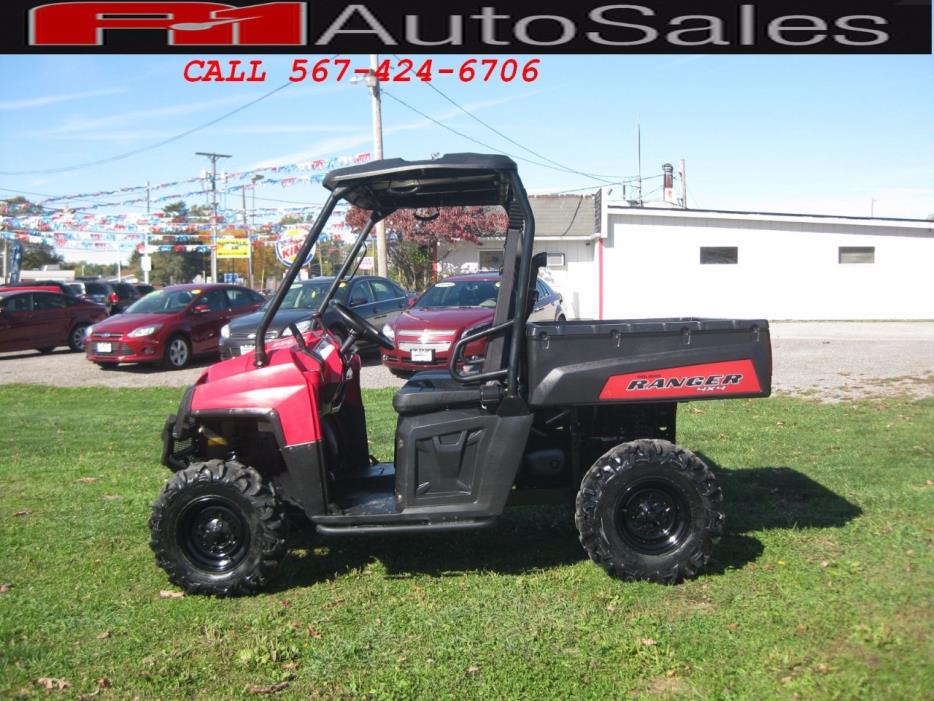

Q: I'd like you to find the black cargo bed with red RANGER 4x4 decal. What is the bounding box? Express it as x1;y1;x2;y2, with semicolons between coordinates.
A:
526;318;772;407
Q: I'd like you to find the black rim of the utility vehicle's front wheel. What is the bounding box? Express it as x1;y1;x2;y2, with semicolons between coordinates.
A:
178;495;250;572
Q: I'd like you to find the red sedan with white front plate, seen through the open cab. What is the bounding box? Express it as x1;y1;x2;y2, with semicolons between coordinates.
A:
382;273;566;377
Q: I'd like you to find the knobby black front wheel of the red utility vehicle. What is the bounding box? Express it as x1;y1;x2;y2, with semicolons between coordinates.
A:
149;460;287;596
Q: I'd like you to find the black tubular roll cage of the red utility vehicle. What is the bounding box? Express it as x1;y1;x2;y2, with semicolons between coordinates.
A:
255;153;535;399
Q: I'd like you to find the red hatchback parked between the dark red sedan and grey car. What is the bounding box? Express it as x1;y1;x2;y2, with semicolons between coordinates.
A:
86;284;265;370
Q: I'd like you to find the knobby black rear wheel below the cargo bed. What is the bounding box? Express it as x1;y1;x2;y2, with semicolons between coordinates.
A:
574;440;723;584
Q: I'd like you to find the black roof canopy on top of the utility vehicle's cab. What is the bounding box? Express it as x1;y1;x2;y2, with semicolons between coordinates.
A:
324;153;517;215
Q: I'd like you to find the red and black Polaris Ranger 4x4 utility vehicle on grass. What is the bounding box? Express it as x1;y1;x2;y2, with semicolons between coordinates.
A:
149;154;771;595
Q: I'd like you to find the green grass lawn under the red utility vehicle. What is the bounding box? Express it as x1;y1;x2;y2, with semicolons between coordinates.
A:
0;385;934;701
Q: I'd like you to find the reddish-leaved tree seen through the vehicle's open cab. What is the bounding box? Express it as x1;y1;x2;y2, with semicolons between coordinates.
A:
346;207;508;290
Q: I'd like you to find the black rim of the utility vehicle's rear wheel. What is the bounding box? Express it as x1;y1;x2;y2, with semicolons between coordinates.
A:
616;479;691;555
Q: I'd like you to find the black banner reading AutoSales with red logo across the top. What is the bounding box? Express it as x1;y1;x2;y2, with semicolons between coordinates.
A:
0;0;931;53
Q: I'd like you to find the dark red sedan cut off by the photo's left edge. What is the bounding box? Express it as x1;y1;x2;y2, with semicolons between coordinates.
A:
0;287;107;353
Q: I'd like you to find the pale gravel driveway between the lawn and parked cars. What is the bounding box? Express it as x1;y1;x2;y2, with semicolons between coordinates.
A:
0;322;934;401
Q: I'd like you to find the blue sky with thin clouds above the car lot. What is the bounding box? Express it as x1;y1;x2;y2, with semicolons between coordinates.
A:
0;55;934;260
